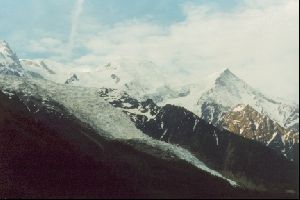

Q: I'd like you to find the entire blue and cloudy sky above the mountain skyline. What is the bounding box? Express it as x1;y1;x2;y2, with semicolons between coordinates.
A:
0;0;299;102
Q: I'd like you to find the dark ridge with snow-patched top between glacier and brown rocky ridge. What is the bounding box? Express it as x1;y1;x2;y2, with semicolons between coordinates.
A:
99;88;297;193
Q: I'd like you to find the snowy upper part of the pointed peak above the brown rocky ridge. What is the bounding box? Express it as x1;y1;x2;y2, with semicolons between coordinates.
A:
197;69;299;132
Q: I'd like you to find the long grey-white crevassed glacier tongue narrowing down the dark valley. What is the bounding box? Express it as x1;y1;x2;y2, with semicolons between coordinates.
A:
0;75;237;186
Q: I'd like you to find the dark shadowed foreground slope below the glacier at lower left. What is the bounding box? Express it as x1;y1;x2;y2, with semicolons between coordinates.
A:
0;92;238;198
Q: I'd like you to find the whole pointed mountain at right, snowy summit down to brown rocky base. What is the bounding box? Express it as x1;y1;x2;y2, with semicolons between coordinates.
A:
161;69;299;160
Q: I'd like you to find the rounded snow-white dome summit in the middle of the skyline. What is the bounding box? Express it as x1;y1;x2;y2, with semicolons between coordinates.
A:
66;59;170;98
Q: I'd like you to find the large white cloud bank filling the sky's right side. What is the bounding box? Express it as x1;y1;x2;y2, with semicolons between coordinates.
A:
70;0;299;100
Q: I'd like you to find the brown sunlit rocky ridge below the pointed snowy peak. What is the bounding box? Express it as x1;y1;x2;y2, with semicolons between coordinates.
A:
221;105;299;160
